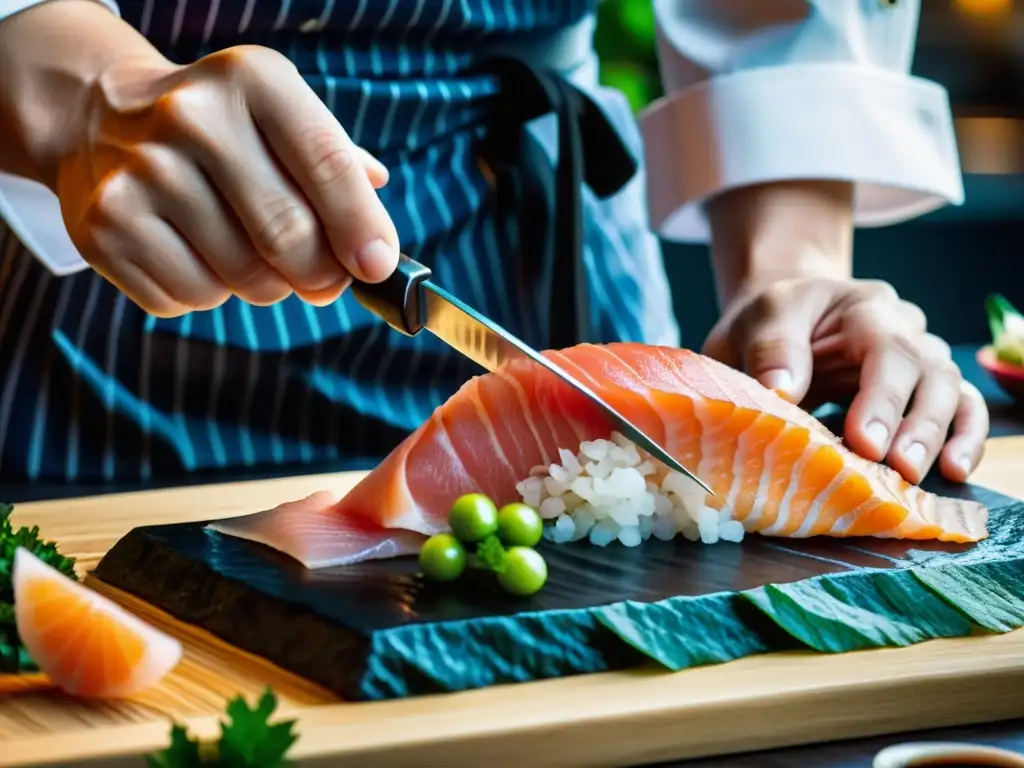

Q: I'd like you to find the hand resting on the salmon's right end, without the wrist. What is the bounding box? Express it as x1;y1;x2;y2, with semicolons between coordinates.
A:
705;275;988;482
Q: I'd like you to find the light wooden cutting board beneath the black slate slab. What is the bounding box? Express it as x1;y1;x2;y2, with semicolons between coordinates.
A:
0;437;1024;766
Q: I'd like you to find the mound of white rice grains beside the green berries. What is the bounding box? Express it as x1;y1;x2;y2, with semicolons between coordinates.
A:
516;432;743;547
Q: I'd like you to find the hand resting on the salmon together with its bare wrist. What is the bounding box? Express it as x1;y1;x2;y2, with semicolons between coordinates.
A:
705;181;988;482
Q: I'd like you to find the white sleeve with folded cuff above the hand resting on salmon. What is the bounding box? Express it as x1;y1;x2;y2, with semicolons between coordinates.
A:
641;0;964;242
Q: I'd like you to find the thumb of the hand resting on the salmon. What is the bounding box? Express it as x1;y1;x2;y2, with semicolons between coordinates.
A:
738;307;814;402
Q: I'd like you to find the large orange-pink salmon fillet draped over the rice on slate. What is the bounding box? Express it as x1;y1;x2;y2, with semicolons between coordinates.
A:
211;343;988;567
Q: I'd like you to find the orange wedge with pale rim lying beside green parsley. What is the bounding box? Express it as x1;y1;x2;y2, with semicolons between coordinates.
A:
11;548;181;697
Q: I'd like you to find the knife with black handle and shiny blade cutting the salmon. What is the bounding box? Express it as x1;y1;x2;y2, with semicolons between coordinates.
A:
352;255;714;496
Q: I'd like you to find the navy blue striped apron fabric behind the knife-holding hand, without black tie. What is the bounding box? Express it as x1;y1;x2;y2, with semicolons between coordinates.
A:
0;0;678;481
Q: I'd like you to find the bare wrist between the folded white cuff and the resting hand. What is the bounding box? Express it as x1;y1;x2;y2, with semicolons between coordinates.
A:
708;181;853;306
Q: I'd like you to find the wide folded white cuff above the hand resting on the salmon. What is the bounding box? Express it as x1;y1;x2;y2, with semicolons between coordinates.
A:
641;63;964;242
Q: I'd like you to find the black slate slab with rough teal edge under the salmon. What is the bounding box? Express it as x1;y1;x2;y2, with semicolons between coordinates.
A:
95;483;1024;699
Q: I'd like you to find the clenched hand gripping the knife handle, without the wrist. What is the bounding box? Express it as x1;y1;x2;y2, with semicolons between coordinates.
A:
56;46;398;317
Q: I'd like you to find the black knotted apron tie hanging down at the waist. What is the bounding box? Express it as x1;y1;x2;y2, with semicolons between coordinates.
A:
481;56;637;349
